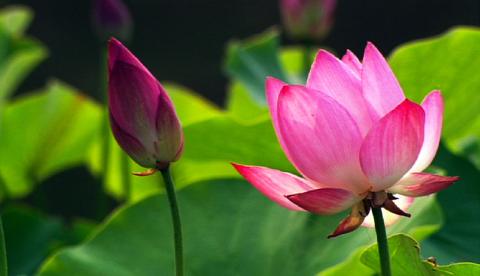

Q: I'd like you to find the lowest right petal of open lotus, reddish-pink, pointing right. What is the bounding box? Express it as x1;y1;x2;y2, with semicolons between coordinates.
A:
388;173;460;197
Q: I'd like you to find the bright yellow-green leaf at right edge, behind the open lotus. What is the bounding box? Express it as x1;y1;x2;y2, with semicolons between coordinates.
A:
390;27;480;167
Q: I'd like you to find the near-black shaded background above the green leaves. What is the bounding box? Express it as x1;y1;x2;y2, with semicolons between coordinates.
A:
0;0;480;104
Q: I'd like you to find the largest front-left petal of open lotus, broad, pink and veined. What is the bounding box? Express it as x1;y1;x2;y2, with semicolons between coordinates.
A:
278;85;367;193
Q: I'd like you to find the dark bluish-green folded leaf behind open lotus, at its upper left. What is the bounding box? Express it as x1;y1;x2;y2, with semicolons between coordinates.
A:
225;30;285;105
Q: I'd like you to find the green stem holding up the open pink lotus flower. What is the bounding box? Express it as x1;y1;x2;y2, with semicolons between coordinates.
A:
372;207;392;276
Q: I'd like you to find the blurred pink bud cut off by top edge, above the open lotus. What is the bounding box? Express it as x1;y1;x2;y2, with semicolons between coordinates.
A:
280;0;337;41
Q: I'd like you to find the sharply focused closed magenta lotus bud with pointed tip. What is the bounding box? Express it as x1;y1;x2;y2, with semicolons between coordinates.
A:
108;38;183;169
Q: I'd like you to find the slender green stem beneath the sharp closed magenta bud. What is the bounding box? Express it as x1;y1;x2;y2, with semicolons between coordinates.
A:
160;167;183;276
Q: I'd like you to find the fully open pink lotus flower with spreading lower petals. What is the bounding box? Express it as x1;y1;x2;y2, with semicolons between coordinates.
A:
233;43;458;236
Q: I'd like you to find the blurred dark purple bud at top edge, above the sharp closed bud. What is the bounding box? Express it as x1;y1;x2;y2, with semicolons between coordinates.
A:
93;0;133;40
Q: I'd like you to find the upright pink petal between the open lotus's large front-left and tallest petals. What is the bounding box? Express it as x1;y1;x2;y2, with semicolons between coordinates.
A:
306;50;377;136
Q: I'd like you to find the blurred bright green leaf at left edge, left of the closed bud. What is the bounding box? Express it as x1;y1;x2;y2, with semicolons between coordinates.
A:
0;82;101;197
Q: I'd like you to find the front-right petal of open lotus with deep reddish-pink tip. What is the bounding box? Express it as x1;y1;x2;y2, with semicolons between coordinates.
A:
360;100;425;192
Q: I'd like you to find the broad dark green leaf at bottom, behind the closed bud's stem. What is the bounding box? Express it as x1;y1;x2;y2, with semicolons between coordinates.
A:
40;181;438;276
